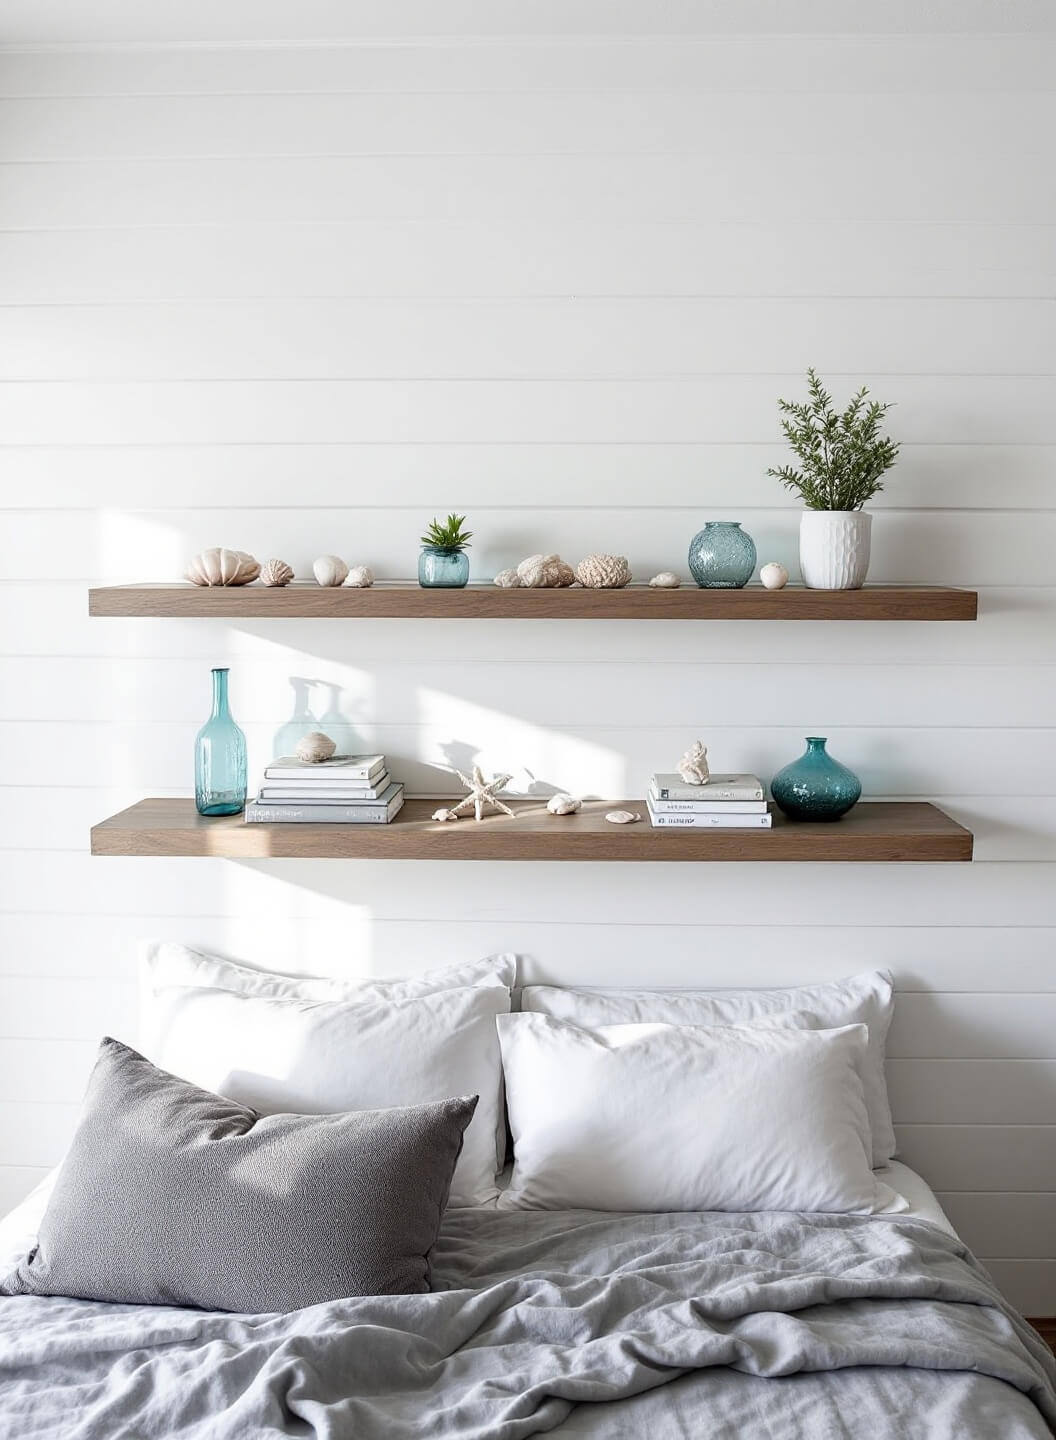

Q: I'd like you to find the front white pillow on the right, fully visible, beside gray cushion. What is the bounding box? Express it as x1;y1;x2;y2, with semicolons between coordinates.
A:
497;1014;906;1214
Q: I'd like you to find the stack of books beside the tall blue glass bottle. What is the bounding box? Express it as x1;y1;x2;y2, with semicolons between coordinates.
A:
245;755;403;825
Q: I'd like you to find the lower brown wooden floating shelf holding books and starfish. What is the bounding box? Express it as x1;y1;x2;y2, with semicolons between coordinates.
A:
92;799;972;863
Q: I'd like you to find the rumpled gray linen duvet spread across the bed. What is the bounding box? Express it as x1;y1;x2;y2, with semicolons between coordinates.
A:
0;1210;1056;1440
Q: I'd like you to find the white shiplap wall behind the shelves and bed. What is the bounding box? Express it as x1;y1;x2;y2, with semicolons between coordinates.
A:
0;0;1056;1313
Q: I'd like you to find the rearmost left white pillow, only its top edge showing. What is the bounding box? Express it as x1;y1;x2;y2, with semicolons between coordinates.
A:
141;940;517;1001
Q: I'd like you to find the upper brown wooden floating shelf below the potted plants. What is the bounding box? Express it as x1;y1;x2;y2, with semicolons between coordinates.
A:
88;582;978;621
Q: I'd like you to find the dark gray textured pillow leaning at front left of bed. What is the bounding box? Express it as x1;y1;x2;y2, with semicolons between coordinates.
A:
0;1038;477;1312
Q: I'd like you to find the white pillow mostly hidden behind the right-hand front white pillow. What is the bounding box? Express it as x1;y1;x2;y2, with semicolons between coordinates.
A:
520;971;896;1165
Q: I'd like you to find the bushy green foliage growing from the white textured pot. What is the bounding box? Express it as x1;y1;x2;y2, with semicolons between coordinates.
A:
766;369;899;510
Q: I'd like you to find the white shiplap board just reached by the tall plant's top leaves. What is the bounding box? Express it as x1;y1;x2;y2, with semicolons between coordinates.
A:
0;297;1056;380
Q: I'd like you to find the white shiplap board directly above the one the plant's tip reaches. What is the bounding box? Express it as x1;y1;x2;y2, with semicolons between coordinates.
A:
0;221;1056;303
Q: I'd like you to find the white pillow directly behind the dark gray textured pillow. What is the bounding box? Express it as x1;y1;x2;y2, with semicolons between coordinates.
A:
147;985;510;1205
